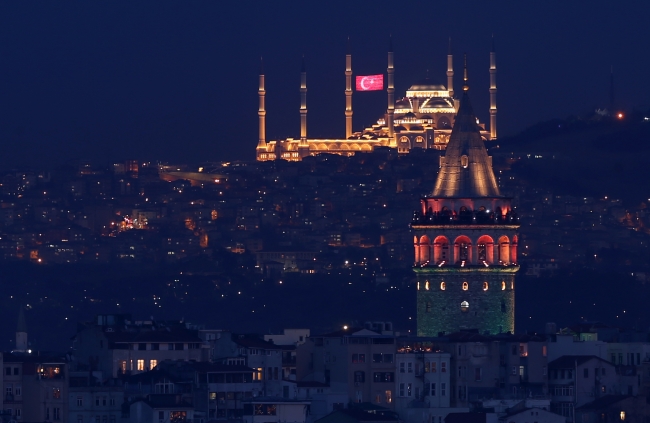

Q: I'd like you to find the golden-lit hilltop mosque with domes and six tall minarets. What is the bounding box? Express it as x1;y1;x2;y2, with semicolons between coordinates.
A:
256;41;497;161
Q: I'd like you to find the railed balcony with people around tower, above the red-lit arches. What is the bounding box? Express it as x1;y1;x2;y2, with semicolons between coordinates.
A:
411;210;519;225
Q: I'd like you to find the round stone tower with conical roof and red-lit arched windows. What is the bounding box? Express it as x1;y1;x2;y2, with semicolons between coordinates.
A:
411;58;519;336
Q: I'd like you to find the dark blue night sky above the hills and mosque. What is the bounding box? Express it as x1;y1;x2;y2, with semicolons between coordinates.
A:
0;0;650;168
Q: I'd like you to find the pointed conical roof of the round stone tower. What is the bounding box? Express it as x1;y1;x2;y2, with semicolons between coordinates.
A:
432;90;501;198
